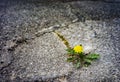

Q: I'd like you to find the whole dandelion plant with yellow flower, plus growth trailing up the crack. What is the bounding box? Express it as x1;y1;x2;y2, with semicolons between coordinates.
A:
55;32;100;68
